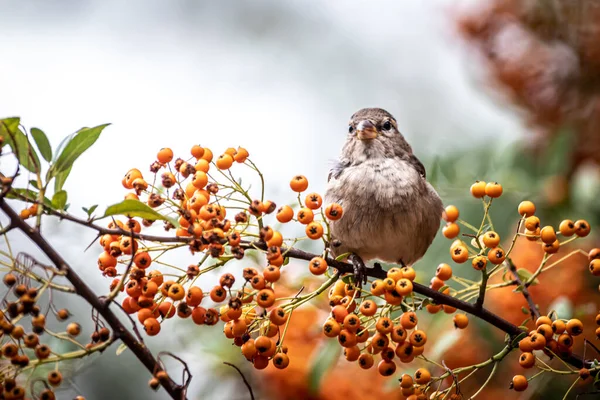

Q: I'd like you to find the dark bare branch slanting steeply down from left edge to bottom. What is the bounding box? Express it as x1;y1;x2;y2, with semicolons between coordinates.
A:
0;198;185;400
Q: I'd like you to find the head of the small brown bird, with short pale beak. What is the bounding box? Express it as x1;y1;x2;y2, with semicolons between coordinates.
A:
342;108;412;163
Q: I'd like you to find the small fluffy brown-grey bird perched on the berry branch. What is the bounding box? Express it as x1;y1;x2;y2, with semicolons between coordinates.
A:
324;108;443;285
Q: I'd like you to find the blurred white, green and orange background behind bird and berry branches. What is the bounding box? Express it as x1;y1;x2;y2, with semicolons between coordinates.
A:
0;0;600;399
